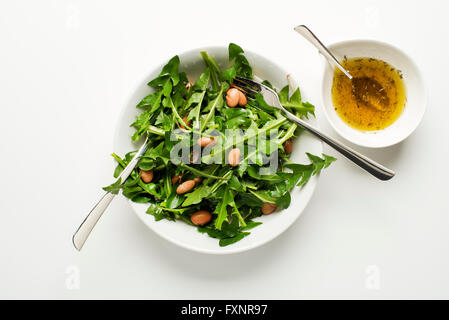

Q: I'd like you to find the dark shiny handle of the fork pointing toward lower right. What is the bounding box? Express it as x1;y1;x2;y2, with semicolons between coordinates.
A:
282;107;395;180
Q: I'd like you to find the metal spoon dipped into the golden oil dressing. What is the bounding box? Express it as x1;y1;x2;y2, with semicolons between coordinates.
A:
295;25;390;111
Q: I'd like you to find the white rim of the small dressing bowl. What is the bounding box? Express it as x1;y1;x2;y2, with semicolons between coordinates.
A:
321;39;428;149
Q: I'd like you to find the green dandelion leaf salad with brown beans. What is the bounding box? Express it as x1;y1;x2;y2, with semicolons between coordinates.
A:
104;43;335;246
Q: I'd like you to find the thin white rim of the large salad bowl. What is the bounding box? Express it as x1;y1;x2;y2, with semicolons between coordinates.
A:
113;45;323;255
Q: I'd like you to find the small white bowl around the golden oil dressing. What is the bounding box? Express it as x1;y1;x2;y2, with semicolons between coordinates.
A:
322;40;427;148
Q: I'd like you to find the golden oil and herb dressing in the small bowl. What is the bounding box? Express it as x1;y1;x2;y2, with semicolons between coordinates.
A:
332;58;406;131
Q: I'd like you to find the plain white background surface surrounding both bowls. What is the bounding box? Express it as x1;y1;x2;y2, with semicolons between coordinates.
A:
0;0;449;299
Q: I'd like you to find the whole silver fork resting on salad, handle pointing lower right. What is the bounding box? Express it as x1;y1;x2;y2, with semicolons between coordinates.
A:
234;77;395;180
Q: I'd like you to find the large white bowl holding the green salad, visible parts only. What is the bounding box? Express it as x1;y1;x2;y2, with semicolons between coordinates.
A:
114;47;322;254
